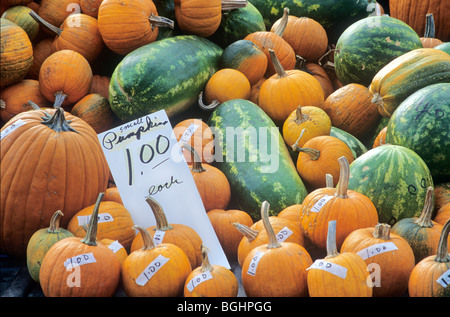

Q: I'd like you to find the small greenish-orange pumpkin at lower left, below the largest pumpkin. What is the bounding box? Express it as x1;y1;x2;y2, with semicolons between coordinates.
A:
27;210;73;282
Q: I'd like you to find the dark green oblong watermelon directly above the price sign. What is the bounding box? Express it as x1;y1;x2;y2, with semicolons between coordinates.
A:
109;35;223;121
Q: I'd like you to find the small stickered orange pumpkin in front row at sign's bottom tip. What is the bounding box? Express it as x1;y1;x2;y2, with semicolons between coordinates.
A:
183;245;239;297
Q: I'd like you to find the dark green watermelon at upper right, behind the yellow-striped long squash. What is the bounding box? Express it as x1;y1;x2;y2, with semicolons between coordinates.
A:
334;16;423;86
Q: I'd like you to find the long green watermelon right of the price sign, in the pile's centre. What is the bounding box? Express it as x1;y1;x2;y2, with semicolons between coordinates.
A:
208;99;307;220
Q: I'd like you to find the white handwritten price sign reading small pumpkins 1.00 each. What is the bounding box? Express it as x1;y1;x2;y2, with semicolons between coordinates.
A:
98;110;230;268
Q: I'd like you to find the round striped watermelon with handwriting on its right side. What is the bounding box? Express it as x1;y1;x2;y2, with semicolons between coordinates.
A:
348;144;433;225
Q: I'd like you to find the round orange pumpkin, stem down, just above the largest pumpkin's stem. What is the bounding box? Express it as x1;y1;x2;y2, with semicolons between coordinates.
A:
39;50;92;108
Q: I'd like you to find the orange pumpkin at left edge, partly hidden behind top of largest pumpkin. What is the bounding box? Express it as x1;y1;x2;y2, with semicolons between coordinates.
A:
0;79;50;122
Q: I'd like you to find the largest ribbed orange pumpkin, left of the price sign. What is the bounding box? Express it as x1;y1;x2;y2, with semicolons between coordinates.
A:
0;108;109;256
